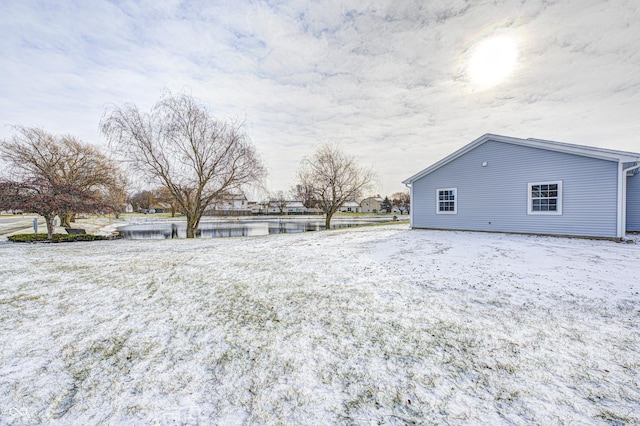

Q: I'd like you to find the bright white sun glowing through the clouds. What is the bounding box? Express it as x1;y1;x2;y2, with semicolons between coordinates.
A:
467;35;518;90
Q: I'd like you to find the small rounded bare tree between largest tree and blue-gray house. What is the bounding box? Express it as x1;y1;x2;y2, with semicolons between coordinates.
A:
298;144;374;229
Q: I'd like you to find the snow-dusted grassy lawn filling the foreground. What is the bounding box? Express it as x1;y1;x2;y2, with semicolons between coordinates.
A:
0;224;640;425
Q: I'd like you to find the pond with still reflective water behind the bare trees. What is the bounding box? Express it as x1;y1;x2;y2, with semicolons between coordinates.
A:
118;217;404;240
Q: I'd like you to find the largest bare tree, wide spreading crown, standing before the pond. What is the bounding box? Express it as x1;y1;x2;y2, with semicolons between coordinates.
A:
101;93;266;238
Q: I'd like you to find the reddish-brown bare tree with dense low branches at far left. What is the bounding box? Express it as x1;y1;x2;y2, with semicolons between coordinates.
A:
0;126;118;237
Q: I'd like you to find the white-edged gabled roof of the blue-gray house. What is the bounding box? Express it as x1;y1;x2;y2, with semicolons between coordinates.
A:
402;133;640;184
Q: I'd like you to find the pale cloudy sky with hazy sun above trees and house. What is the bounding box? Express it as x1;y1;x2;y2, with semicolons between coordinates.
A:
0;0;640;194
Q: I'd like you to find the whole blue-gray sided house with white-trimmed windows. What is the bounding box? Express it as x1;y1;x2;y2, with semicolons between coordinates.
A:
403;134;640;238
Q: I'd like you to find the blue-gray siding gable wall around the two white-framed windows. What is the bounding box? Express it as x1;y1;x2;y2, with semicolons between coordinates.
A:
412;141;618;238
